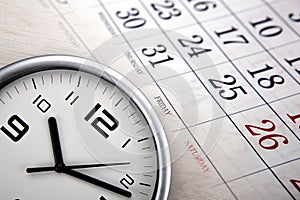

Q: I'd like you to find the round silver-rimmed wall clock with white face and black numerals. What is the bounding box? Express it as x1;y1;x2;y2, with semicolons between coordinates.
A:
0;55;171;200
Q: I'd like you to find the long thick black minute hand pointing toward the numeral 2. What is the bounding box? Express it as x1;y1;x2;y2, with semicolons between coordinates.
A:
61;167;132;198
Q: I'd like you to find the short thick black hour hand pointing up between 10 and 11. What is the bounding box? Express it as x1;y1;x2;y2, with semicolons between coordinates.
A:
48;117;65;172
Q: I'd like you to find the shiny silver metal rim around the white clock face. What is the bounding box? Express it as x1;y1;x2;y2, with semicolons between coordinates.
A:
0;55;171;200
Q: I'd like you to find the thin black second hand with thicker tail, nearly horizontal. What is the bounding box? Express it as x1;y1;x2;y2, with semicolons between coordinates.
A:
26;162;130;173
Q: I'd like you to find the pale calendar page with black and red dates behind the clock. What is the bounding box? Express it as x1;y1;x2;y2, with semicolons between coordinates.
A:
0;0;300;200
